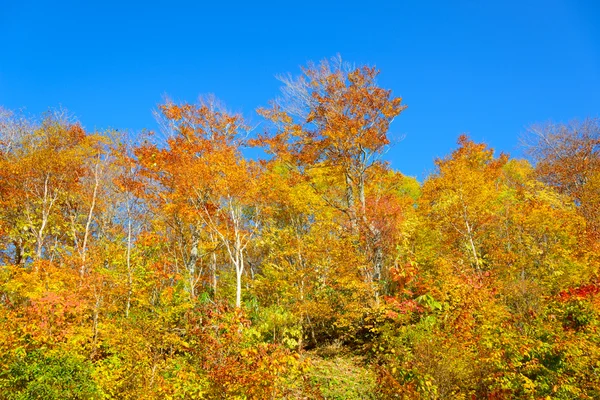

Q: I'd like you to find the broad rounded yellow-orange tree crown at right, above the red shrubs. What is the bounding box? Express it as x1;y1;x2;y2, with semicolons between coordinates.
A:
418;136;586;290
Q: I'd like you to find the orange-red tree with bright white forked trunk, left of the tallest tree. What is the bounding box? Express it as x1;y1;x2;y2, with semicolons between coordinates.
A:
136;99;259;307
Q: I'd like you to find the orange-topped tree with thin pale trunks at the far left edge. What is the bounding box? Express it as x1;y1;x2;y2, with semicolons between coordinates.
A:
3;111;107;275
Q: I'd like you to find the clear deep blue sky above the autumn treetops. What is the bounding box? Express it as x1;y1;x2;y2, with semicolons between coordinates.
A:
0;0;600;178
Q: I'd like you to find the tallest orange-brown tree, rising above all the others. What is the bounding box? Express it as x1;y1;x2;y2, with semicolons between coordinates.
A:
259;57;405;294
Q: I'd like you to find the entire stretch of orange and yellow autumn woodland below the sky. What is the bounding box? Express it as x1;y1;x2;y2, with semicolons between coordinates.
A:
0;59;600;399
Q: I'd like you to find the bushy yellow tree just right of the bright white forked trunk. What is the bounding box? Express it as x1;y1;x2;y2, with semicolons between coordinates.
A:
252;160;370;348
